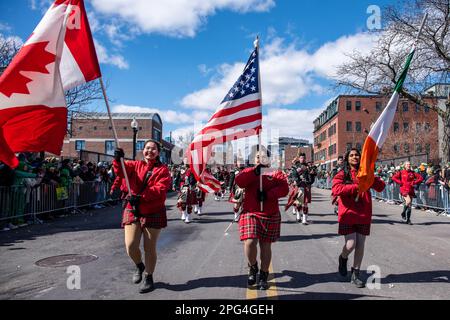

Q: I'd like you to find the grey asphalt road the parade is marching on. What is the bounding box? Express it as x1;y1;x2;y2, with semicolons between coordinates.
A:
0;189;450;300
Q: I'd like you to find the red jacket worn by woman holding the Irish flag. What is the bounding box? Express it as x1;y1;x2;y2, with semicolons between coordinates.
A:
332;170;385;225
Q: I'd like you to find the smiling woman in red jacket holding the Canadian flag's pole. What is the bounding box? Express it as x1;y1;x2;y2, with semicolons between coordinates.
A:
113;140;171;293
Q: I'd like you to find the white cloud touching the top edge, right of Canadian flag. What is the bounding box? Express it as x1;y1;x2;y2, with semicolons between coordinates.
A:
92;0;275;37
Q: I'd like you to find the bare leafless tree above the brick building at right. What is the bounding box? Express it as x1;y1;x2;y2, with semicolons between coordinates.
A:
335;0;450;162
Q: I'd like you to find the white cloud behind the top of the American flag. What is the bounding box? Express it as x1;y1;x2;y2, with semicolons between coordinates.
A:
181;33;376;110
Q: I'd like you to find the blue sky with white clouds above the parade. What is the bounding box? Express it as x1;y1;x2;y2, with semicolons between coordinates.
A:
0;0;395;140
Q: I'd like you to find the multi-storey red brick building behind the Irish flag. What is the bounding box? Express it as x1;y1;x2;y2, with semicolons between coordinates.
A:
314;95;439;170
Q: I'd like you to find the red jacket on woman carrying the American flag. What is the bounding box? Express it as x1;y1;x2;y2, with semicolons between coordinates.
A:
235;167;289;215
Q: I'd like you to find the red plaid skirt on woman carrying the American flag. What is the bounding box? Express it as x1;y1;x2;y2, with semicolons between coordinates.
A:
239;212;281;242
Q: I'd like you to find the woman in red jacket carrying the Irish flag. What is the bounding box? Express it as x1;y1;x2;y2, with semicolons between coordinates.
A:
332;148;385;288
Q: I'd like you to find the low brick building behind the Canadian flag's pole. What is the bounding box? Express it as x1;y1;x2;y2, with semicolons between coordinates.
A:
61;113;173;163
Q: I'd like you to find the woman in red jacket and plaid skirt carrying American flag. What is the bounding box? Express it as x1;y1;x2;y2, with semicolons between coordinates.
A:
235;151;289;290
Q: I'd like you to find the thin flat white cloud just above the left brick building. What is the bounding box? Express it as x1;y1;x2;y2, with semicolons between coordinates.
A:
113;104;211;124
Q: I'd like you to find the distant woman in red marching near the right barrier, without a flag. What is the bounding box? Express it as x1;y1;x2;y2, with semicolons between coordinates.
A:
392;161;423;224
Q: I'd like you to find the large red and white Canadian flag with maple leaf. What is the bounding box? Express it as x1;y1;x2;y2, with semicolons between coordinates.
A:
0;0;100;168
